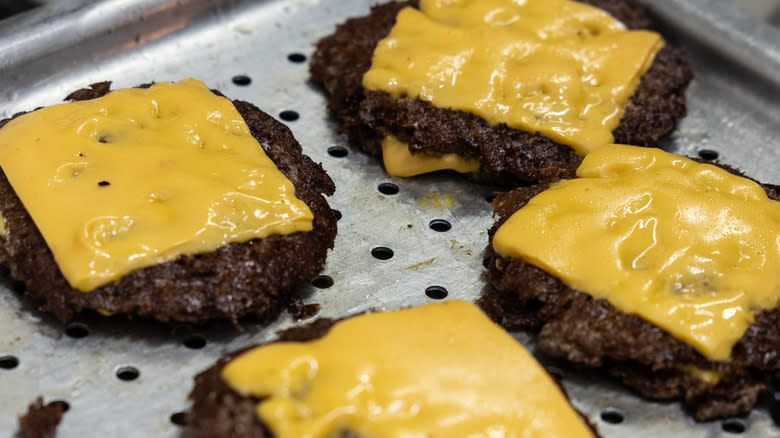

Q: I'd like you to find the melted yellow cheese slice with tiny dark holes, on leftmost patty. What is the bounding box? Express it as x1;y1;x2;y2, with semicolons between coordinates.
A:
0;79;312;291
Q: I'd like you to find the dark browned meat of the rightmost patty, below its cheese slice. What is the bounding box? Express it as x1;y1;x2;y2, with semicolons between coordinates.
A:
479;166;780;421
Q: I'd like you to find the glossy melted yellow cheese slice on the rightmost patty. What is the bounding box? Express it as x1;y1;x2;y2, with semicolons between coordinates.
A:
493;145;780;361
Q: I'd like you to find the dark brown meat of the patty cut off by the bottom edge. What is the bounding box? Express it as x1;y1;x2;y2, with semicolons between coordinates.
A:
188;318;597;438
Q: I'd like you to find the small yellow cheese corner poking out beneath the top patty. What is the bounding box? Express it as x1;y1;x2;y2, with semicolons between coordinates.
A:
382;135;479;177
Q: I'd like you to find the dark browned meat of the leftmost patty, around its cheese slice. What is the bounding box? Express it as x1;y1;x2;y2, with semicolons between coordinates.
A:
0;82;336;322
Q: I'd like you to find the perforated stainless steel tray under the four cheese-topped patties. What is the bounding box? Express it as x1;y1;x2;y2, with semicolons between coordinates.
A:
0;0;780;438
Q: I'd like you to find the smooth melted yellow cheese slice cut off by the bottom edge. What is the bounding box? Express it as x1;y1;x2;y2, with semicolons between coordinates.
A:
222;301;593;438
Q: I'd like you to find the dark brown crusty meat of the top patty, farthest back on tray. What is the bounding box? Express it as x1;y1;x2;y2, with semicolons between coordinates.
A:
310;0;693;185
